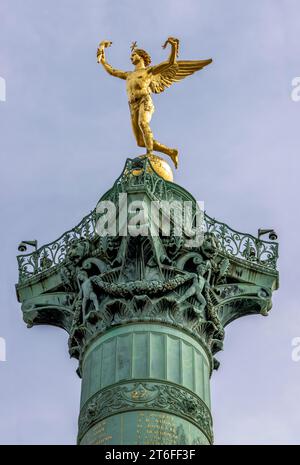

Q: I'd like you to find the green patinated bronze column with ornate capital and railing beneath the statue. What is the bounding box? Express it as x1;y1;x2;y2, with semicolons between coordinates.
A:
16;159;278;444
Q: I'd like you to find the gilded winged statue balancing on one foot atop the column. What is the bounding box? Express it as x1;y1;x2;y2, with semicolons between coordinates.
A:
97;37;212;168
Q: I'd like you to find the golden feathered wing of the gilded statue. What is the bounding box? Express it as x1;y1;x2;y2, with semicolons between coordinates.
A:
150;58;212;94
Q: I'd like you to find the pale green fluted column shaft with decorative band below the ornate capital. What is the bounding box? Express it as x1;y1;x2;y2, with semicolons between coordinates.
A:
78;323;212;445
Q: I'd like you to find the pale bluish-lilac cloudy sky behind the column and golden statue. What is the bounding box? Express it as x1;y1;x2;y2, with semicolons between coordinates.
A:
0;0;300;444
